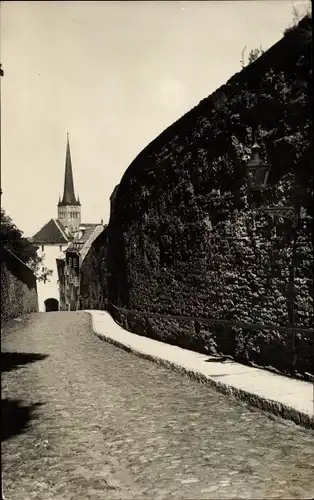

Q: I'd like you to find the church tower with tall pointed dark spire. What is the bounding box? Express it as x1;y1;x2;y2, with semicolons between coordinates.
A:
58;134;81;233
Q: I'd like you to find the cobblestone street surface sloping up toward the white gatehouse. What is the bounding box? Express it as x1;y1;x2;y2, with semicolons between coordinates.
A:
2;312;314;500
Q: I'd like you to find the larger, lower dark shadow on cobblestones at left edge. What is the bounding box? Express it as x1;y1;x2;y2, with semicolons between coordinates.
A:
1;398;43;442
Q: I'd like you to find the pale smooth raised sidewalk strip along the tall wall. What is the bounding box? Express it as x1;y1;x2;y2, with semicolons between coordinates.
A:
85;310;314;428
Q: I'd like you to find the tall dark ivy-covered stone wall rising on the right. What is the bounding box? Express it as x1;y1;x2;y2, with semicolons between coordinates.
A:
80;19;314;377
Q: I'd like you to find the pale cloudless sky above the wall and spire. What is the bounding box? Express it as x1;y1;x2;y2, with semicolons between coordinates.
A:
0;0;308;236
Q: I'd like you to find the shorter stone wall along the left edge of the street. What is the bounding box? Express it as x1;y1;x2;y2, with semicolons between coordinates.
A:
1;247;38;323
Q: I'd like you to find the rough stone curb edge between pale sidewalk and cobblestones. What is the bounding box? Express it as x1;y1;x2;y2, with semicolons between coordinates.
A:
86;311;314;429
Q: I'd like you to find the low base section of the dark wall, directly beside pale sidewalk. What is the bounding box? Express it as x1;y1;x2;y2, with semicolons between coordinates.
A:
107;304;314;381
